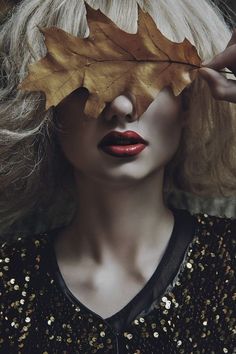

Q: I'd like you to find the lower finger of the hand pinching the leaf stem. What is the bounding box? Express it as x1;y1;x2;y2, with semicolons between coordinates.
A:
199;68;236;103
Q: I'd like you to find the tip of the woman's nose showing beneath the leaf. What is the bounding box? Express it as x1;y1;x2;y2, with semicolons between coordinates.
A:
104;95;137;122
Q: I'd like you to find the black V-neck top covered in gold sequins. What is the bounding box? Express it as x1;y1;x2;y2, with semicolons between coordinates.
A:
0;209;236;354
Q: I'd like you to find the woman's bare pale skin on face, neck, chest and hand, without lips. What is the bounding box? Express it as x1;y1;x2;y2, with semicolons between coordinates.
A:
52;32;236;318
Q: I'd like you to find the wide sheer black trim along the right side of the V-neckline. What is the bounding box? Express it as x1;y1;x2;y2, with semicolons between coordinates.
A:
106;209;195;330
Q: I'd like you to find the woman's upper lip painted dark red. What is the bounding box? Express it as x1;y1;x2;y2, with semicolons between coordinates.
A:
98;130;148;146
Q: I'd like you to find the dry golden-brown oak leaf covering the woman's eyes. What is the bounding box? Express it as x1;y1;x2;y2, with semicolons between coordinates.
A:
19;5;201;118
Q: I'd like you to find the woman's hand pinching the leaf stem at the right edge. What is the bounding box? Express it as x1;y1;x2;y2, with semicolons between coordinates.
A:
199;29;236;103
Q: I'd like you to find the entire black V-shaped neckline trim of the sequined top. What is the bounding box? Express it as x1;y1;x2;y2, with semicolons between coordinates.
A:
48;209;196;332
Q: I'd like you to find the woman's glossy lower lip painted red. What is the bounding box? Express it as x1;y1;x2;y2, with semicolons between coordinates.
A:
98;144;147;157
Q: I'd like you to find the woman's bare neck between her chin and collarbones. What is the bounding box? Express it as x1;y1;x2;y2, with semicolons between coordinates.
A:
62;171;173;263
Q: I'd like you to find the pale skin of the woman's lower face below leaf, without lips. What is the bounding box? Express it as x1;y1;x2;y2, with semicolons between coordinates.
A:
57;89;181;187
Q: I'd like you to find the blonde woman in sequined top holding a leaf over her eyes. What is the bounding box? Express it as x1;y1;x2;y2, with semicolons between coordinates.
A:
0;0;236;354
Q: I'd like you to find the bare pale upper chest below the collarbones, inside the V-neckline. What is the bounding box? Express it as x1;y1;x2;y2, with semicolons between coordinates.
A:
59;262;153;318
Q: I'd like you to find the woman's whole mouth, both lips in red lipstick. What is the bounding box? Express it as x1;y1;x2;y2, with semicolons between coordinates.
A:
98;130;148;157
